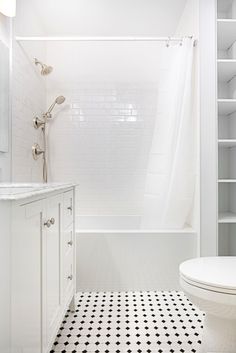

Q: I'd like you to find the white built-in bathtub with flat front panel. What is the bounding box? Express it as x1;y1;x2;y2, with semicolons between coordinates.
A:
77;216;197;291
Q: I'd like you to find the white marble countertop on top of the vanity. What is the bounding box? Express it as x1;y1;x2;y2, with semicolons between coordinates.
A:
0;183;77;201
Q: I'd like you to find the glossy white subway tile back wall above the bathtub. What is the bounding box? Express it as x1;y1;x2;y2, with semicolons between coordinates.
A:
47;82;158;215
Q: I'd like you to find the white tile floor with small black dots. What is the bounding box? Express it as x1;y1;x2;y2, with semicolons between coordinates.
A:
51;292;204;353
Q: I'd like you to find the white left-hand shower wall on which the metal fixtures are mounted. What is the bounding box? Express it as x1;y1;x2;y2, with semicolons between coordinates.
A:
12;10;47;182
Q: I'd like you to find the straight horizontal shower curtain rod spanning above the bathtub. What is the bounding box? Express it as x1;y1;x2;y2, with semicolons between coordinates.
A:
16;36;193;42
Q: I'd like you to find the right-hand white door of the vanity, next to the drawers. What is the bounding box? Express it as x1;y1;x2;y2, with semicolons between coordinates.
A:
43;195;62;351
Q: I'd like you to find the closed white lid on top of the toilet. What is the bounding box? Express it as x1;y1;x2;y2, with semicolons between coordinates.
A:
179;256;236;290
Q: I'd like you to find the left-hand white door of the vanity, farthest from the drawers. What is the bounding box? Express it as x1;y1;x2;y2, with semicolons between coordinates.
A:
11;201;44;353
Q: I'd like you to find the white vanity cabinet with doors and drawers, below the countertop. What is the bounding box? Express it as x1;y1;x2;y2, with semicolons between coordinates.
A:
11;188;75;353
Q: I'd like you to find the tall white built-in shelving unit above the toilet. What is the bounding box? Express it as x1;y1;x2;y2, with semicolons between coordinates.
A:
217;0;236;255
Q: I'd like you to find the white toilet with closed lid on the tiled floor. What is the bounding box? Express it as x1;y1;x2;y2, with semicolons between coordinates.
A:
179;256;236;353
